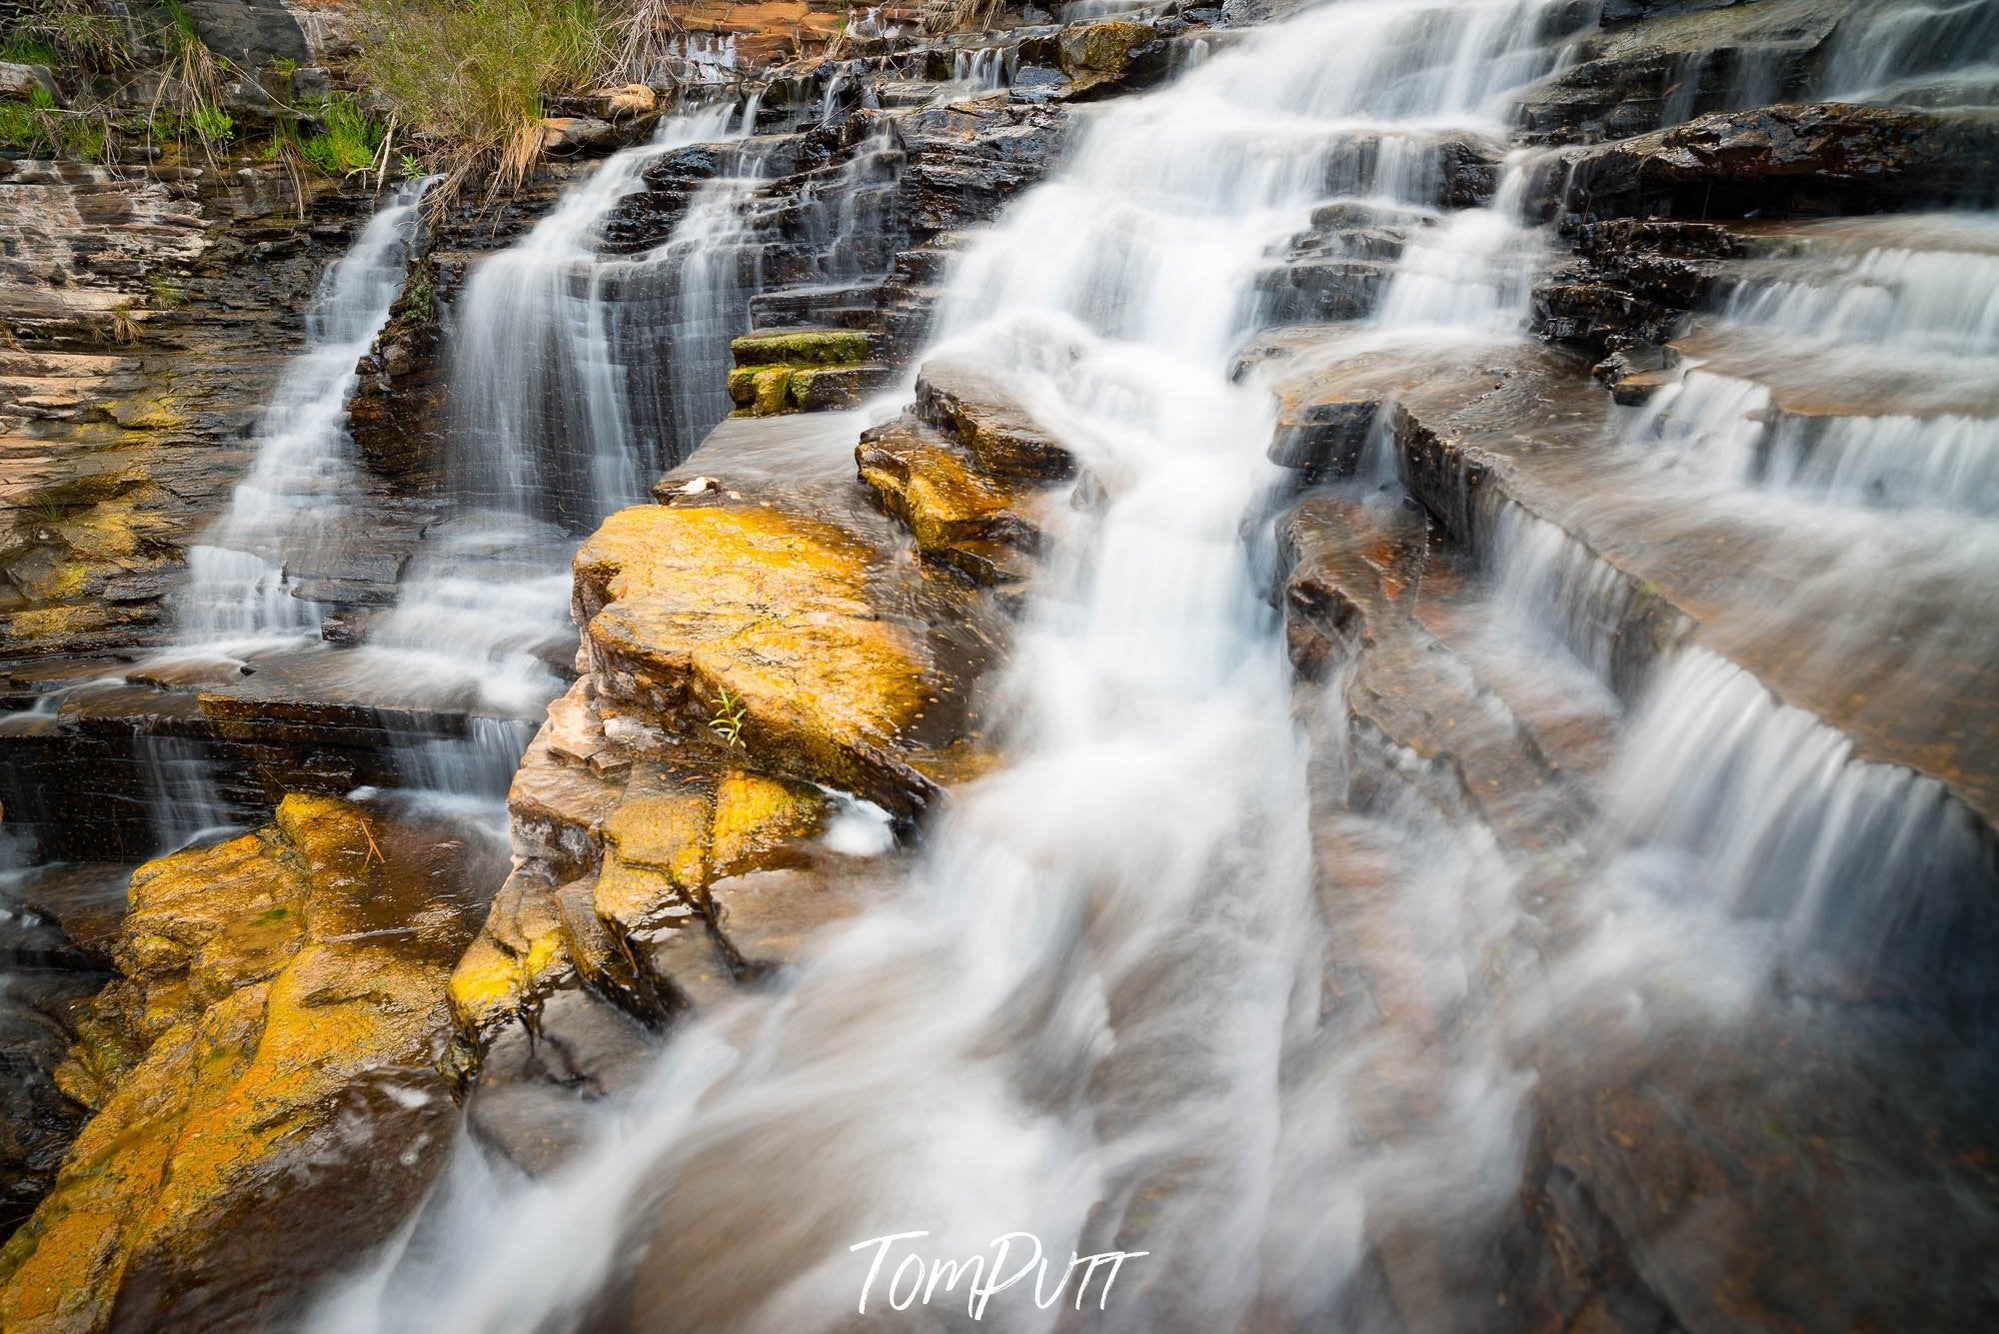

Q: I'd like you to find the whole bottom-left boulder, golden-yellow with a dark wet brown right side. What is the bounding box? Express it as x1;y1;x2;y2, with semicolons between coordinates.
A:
0;796;496;1332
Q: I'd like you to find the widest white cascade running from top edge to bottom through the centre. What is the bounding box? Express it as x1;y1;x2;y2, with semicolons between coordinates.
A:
324;0;1623;1330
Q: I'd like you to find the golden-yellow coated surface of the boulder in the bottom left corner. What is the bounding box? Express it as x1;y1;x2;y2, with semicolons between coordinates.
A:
0;796;475;1334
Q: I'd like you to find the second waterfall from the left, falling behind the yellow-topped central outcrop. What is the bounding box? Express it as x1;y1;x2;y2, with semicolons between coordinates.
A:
331;96;758;748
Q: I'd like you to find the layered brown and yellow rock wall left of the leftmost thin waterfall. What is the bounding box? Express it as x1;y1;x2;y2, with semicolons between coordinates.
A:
0;162;366;662
